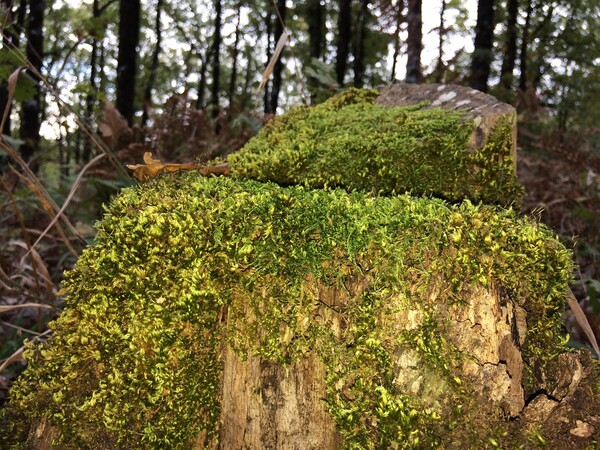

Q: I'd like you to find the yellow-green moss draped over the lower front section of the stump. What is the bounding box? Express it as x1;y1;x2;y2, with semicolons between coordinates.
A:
11;173;572;448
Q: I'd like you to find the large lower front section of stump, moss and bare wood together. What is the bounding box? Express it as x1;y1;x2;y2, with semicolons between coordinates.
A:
0;173;600;449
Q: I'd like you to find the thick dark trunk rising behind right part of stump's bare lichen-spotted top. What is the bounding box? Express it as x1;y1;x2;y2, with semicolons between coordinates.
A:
471;0;494;92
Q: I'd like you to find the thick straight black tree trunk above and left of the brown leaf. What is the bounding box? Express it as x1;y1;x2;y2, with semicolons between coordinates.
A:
117;0;140;125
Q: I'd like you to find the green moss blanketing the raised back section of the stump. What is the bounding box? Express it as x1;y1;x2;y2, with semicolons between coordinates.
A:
229;89;523;205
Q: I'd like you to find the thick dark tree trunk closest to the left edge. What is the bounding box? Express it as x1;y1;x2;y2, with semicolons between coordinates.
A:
20;0;45;162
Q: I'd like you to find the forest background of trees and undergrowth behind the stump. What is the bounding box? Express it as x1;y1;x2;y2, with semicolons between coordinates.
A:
0;0;600;405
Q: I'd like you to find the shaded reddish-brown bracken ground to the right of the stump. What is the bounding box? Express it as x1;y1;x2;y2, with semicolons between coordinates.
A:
518;129;600;345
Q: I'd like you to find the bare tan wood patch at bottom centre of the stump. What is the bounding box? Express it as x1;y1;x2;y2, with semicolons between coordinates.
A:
215;347;342;450
